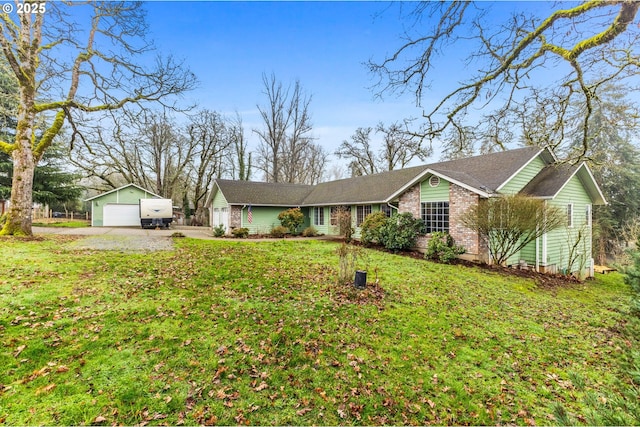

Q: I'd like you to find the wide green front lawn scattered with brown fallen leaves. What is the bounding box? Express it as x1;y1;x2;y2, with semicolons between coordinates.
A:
0;236;640;425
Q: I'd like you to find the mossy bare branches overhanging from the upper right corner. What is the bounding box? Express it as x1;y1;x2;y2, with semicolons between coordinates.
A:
369;0;640;157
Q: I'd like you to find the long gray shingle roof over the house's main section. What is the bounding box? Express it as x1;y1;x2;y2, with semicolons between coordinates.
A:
216;147;542;206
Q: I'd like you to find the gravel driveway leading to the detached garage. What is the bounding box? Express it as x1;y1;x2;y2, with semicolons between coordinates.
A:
33;227;212;252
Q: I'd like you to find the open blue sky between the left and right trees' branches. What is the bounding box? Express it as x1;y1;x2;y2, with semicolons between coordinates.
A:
146;1;444;166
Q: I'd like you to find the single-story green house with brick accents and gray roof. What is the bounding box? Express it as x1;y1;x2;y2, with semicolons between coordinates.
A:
208;147;606;275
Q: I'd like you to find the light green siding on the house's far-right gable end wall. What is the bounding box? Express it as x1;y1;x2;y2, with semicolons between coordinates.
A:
546;176;592;280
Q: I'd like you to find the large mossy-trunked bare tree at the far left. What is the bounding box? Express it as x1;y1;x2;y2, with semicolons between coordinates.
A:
0;2;195;235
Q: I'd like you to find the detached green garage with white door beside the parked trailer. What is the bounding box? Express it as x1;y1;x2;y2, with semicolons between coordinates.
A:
85;184;161;227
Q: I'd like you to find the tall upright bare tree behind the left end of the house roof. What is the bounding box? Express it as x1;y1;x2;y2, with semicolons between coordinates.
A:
254;74;319;183
